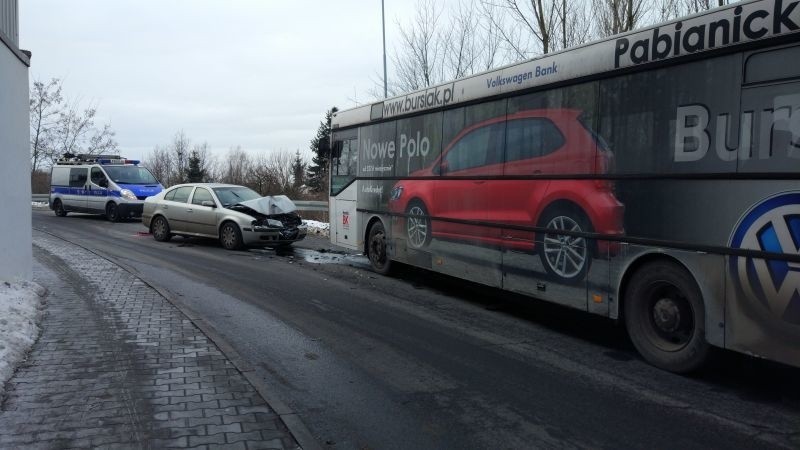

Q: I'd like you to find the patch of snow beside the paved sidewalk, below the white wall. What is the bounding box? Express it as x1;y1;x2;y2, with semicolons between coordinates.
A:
0;282;44;396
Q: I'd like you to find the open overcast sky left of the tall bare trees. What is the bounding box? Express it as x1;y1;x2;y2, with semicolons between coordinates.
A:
19;0;414;162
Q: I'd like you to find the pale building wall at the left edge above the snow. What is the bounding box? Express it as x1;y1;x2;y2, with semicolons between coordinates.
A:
0;0;33;281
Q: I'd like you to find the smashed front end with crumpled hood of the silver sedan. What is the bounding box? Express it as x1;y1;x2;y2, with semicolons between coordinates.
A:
230;194;308;246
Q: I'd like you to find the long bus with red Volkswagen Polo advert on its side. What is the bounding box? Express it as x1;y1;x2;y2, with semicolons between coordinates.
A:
330;0;800;373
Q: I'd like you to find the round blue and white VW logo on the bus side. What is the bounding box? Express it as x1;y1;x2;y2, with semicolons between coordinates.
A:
730;192;800;325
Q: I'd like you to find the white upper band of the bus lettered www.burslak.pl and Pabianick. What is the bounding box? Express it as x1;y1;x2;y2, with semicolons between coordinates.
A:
332;0;800;128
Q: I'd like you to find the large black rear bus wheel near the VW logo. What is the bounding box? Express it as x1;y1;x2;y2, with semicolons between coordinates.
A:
623;261;710;373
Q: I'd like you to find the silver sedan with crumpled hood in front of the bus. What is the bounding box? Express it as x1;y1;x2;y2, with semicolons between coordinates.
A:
142;183;307;250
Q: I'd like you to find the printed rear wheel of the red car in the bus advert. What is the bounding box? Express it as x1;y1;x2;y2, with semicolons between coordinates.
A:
539;208;592;283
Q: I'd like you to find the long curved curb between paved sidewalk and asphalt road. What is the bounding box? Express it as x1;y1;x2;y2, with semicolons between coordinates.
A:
35;228;323;450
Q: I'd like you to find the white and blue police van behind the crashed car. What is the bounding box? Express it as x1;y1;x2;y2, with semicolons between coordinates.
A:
50;154;164;222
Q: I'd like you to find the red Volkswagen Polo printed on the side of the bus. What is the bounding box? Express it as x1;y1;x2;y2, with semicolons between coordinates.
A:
389;109;624;281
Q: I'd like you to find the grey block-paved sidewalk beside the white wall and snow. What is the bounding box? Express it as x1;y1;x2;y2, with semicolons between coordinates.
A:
0;233;298;449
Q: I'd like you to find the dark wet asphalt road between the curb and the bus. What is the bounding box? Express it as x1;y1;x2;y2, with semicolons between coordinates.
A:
33;210;800;449
